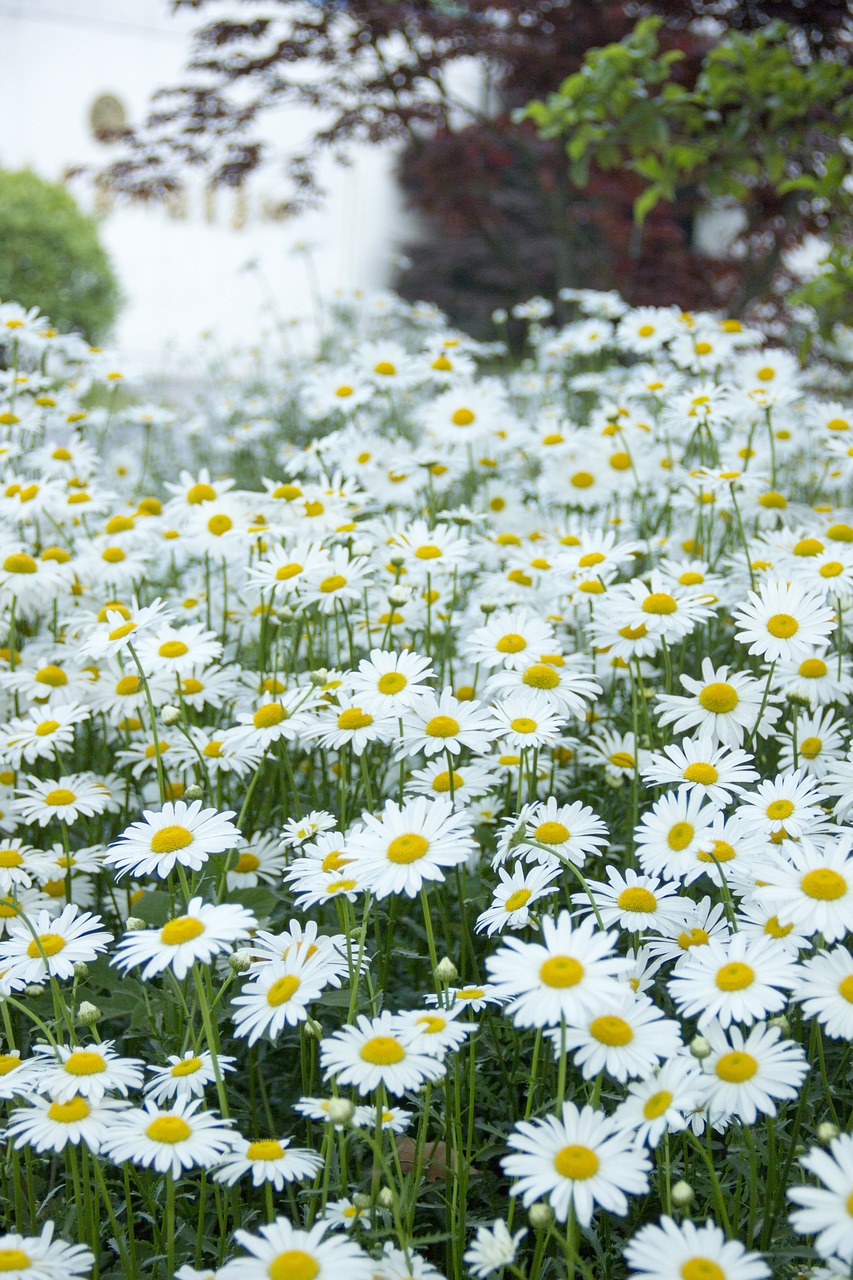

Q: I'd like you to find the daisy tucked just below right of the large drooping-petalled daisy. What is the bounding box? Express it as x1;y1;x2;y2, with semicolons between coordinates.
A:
546;987;681;1083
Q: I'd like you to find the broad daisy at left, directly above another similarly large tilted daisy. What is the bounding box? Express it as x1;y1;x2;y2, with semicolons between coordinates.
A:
104;800;242;878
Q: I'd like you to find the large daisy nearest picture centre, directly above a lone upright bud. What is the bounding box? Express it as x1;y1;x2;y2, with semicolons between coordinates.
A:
347;796;475;899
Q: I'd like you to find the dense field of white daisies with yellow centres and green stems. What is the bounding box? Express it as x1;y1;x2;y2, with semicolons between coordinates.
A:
0;293;853;1280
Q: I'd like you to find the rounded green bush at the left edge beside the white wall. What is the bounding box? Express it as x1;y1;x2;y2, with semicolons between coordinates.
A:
0;169;120;342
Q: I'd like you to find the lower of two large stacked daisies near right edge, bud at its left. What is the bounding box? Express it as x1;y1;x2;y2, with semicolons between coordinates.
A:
701;1023;808;1129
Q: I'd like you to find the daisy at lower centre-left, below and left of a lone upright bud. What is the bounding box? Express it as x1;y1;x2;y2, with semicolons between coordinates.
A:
320;1011;444;1097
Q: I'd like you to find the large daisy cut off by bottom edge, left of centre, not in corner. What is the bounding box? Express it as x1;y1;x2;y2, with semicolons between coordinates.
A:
216;1217;375;1280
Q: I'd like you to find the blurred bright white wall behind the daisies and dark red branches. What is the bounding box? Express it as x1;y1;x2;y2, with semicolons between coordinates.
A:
0;0;410;370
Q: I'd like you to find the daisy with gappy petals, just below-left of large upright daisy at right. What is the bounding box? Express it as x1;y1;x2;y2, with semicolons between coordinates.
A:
657;658;781;746
